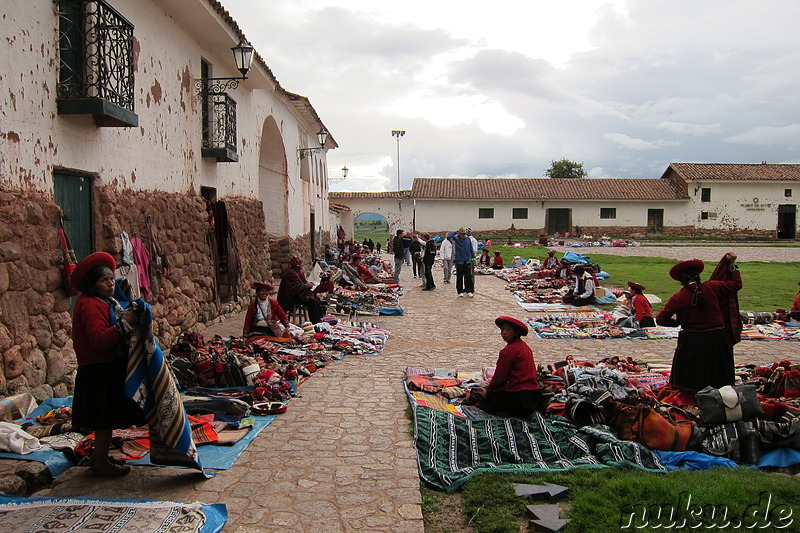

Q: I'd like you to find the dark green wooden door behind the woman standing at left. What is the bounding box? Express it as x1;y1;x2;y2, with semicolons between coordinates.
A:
53;170;94;261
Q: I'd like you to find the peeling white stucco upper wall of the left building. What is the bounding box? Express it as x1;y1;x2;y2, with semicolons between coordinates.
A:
0;0;329;236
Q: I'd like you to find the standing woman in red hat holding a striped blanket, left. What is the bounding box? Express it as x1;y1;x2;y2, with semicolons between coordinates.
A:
71;252;145;476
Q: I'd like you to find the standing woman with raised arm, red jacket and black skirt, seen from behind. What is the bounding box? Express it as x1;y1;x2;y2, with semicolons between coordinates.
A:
656;252;742;392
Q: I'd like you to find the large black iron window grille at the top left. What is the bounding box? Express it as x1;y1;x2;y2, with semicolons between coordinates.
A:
57;0;138;126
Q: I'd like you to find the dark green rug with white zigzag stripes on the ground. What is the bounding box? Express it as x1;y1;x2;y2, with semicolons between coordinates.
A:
414;406;666;492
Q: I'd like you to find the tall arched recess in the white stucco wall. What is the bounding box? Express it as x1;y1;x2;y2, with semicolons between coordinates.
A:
258;115;289;235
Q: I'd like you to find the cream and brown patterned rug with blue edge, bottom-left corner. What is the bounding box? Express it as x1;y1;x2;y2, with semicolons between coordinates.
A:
0;495;228;533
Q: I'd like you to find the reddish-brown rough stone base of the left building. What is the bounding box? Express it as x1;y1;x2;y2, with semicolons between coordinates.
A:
0;186;273;401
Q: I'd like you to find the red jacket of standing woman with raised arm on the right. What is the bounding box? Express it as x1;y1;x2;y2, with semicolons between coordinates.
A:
656;270;742;331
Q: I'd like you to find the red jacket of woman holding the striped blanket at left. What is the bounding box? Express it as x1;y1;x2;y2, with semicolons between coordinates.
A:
72;294;122;365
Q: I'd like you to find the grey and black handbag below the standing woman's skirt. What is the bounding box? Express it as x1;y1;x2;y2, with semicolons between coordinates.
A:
697;385;764;424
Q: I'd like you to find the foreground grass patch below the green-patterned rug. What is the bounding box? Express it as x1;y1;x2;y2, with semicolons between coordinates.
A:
422;467;800;533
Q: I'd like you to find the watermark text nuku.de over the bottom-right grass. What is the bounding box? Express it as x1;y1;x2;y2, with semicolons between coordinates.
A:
619;491;794;531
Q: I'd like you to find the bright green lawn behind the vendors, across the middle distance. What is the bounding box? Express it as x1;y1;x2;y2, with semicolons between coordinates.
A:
492;246;800;312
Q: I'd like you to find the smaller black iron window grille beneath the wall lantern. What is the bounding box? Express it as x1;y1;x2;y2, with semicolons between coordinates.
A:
202;92;239;162
